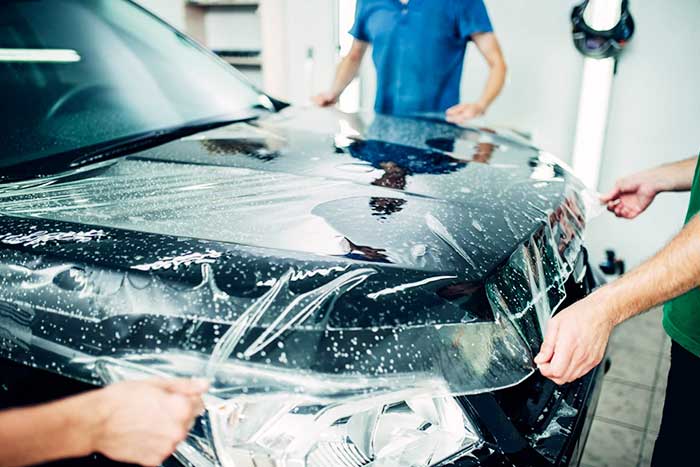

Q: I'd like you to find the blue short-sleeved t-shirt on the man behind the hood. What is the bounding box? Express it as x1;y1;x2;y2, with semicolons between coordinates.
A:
350;0;493;115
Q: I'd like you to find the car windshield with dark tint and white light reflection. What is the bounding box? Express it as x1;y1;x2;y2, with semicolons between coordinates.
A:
0;0;269;176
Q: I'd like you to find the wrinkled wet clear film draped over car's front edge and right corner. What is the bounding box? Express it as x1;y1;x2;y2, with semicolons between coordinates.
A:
0;185;583;398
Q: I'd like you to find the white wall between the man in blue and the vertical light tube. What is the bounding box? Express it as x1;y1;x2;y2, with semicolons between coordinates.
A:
462;0;583;162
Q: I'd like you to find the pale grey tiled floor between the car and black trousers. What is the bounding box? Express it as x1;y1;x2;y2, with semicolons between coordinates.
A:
582;309;671;467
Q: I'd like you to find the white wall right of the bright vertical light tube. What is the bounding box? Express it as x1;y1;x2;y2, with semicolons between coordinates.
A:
588;0;700;265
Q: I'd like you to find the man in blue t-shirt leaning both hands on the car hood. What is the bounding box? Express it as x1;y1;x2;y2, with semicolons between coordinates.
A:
314;0;506;123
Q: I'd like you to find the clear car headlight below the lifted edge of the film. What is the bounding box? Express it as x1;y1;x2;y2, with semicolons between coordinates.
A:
198;395;480;467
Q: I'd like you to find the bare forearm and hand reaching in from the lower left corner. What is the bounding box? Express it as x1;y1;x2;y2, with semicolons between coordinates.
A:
0;379;207;467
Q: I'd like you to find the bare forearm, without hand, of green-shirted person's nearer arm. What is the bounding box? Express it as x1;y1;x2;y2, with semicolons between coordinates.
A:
594;212;700;324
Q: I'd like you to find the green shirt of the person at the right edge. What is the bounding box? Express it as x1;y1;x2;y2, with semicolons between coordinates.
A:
663;158;700;357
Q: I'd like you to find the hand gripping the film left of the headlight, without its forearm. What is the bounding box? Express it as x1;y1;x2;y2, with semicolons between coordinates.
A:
91;379;209;466
